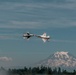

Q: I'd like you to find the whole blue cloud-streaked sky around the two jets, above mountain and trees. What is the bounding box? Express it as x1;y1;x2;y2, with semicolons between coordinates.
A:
0;0;76;68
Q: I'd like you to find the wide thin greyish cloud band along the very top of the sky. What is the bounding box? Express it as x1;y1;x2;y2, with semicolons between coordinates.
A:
0;0;76;11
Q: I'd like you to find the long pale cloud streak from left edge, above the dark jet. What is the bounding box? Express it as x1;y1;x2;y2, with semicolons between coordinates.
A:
0;21;44;29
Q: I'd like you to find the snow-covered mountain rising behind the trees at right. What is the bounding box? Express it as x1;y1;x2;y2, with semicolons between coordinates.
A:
37;51;76;68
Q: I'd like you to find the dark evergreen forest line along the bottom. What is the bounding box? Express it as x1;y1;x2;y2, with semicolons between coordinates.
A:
0;66;76;75
